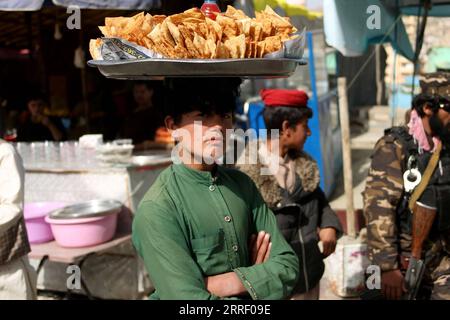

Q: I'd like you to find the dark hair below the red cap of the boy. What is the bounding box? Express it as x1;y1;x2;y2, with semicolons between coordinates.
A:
264;107;313;137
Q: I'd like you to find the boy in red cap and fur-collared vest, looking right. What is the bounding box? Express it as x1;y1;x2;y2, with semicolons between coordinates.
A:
237;89;342;300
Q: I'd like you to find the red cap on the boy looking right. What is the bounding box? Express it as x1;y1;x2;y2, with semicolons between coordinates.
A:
260;89;308;108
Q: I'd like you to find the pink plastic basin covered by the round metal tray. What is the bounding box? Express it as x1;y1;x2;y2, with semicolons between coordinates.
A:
45;213;118;248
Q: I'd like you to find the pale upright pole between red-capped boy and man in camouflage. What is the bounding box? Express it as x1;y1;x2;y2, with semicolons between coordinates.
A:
338;77;356;238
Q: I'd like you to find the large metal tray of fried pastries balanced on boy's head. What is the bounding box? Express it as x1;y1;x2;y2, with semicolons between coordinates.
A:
88;58;306;80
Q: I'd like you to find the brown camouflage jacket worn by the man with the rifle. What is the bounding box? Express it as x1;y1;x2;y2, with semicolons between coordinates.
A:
364;127;450;271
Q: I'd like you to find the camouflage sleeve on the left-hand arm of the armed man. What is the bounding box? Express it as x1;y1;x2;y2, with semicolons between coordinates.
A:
363;126;411;271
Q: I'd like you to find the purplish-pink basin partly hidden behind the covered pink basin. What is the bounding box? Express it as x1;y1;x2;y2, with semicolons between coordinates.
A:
23;202;67;244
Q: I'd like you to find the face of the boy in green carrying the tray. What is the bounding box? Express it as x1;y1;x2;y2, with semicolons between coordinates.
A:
166;111;233;164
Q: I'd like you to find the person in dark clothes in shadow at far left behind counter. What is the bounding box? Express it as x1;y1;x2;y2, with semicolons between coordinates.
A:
17;95;65;141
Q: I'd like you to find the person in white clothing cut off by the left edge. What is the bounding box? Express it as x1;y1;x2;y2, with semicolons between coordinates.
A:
0;140;36;300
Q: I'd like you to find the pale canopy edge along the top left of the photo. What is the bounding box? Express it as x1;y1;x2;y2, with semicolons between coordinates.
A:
0;0;161;11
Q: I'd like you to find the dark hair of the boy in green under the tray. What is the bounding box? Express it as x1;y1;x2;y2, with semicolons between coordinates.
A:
164;78;241;123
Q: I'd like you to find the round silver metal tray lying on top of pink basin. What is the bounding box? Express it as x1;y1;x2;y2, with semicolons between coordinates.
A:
49;200;122;219
